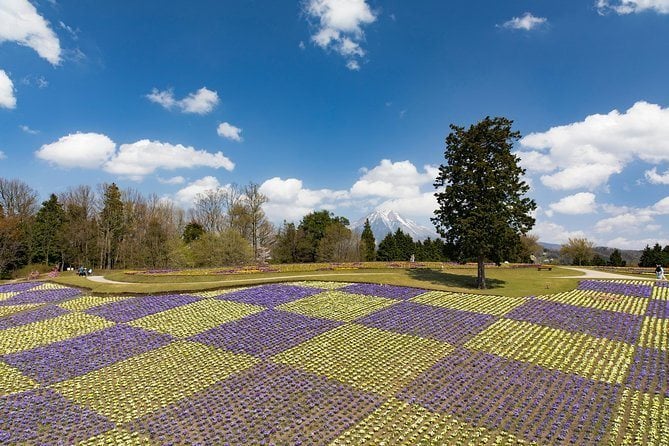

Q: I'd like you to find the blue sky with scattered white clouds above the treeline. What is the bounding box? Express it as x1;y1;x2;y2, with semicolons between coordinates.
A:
0;0;669;249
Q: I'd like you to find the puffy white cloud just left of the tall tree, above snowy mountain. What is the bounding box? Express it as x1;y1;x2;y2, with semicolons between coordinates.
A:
351;159;438;198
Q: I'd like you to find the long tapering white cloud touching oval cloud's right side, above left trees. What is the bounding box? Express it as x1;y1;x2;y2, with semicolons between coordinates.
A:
103;139;235;180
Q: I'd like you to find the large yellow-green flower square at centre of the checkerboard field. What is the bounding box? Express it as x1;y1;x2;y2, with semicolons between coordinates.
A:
272;324;453;394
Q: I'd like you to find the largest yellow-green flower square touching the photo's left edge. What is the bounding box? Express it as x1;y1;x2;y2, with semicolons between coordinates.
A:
0;313;113;355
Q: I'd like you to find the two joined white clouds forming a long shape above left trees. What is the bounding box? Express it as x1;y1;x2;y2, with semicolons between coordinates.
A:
35;133;235;181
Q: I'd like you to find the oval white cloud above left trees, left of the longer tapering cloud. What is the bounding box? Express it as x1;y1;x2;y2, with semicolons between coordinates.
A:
35;133;116;169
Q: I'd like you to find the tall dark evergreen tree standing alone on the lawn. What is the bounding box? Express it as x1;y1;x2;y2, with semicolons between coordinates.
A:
432;117;536;288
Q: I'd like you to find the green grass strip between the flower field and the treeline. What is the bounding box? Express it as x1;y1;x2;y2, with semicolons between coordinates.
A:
55;268;578;296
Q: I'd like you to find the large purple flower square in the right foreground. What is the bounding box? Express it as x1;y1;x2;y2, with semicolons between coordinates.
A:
398;348;620;444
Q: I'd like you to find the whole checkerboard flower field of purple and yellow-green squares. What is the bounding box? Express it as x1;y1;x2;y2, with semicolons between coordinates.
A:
0;278;669;445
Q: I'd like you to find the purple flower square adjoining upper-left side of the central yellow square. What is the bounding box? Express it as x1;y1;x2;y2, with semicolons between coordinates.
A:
192;309;339;358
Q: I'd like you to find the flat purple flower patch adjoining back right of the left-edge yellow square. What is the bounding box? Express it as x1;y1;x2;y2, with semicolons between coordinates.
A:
86;294;200;322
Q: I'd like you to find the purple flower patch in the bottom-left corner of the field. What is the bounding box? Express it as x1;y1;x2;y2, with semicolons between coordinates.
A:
0;389;114;445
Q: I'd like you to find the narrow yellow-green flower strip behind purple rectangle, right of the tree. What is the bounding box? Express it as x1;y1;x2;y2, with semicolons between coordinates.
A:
537;290;648;316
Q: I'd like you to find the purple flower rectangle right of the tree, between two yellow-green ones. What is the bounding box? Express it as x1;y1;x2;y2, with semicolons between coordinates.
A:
505;299;643;344
